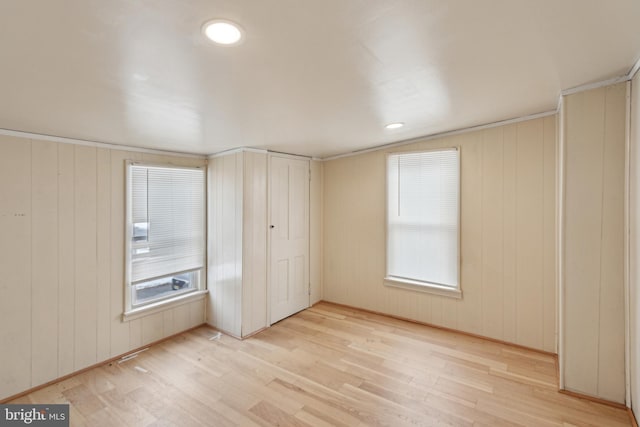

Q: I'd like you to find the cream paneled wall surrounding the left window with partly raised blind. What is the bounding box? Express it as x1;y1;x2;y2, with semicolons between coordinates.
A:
0;136;204;399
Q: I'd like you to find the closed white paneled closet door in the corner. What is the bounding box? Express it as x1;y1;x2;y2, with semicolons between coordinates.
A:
269;155;309;323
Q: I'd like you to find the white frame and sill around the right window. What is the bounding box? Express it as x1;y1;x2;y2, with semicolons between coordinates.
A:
383;146;462;299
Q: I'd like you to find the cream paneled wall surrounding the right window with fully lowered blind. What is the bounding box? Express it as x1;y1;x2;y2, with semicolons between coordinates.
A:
323;116;557;352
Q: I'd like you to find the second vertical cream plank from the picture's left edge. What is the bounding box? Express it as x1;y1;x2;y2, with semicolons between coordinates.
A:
31;141;58;384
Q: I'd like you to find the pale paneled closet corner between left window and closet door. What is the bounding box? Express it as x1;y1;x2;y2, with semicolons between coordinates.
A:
207;152;268;337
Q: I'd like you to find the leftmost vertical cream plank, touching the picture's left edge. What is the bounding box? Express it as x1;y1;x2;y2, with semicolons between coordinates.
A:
0;136;32;395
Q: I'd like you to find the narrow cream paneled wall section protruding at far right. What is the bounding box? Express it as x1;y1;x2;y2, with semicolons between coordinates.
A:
561;83;627;403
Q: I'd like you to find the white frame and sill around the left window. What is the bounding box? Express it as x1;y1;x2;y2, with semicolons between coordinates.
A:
122;160;208;322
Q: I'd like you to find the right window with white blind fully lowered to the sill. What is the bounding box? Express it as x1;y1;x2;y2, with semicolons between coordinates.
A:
385;148;461;297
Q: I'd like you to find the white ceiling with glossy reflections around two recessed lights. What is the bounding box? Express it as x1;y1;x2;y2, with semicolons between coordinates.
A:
0;0;640;157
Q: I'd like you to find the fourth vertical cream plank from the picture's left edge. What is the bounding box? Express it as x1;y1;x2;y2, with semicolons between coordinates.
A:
74;146;98;370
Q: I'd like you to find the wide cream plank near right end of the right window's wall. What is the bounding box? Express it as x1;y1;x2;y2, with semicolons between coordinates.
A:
516;120;544;348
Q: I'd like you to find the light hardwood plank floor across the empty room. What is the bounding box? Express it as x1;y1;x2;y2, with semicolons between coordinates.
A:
11;303;631;427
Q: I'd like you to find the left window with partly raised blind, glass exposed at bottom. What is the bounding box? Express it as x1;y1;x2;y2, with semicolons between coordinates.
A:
125;163;205;315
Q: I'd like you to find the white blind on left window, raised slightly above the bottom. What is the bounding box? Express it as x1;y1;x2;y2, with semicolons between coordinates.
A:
129;164;205;284
